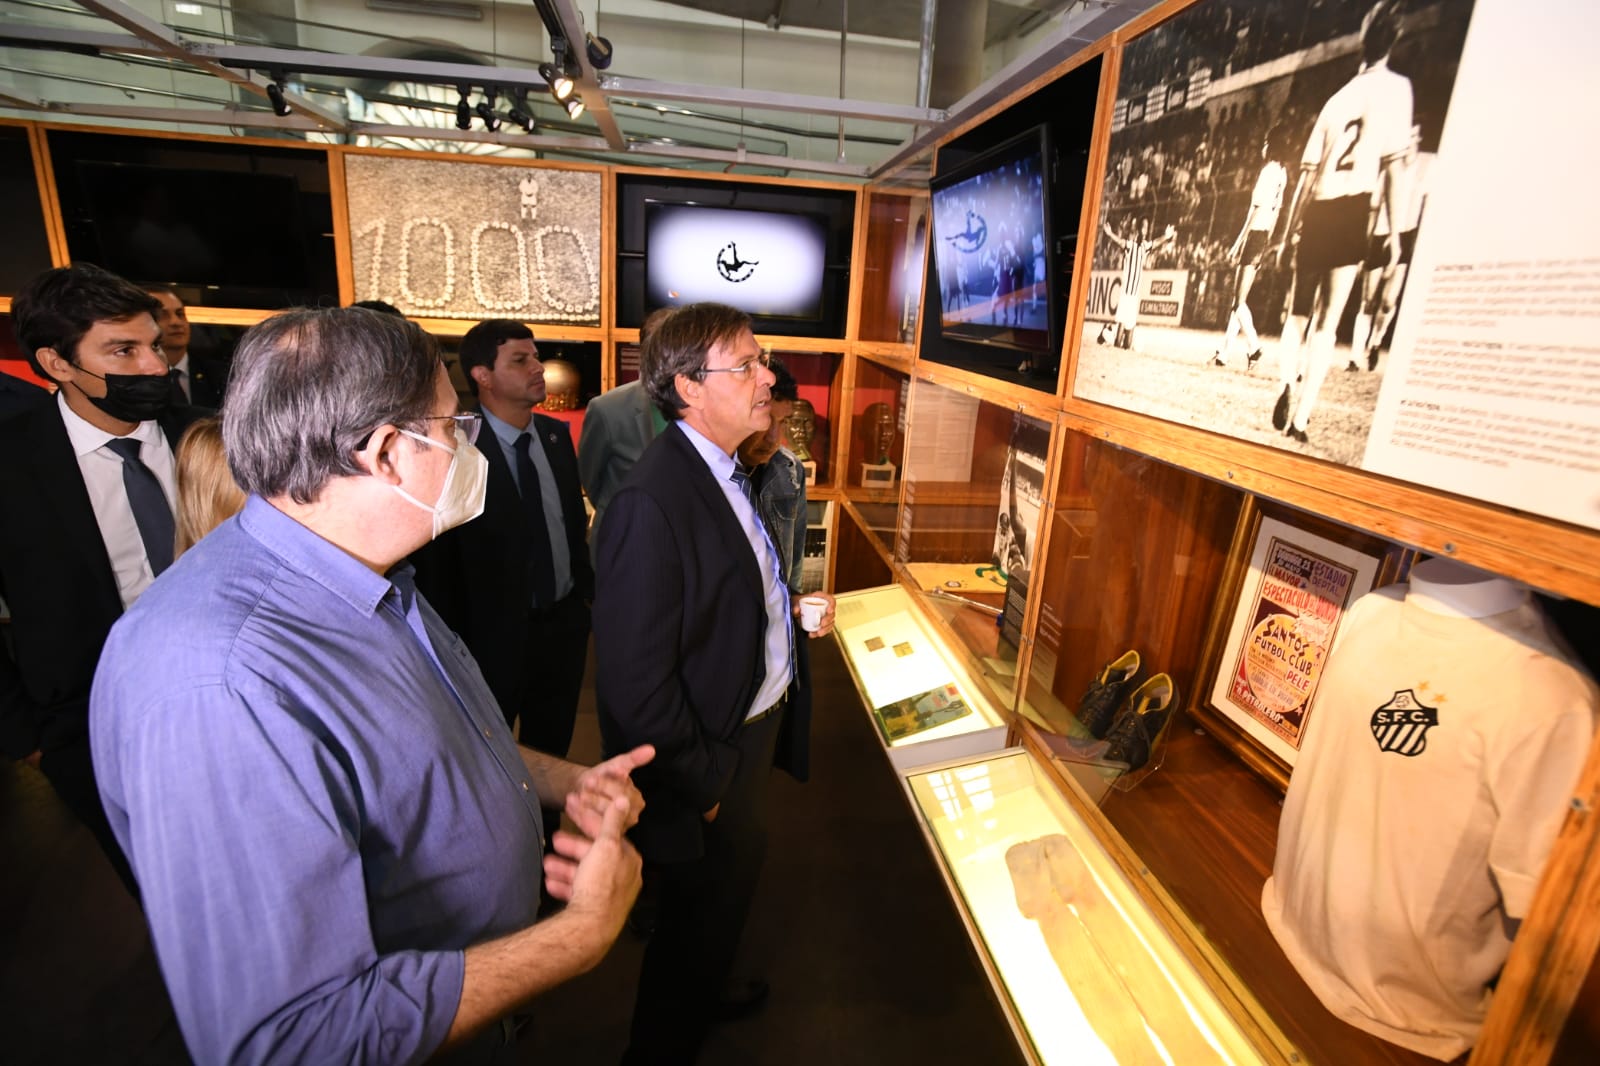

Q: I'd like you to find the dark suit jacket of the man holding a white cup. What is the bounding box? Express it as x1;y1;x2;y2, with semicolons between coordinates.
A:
594;427;810;861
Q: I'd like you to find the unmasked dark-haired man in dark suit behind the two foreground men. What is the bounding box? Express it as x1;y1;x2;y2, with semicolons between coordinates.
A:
413;319;594;771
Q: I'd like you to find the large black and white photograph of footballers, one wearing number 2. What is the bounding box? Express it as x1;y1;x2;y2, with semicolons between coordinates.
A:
1074;0;1474;466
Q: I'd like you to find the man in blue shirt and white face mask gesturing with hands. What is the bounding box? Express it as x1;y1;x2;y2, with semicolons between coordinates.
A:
90;302;653;1063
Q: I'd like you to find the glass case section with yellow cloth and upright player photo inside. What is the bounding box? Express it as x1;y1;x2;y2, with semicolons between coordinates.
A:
893;381;1051;707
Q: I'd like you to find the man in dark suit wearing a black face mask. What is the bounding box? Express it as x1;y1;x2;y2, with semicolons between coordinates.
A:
0;264;206;890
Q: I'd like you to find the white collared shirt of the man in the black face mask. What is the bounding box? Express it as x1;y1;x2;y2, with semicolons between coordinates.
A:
56;386;178;608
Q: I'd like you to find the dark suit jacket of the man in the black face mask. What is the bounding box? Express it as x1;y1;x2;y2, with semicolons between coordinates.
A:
0;403;202;759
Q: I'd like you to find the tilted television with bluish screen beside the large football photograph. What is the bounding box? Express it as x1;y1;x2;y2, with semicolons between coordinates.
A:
931;126;1054;352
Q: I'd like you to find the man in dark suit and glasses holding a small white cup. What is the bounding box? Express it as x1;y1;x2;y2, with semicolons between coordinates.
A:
594;304;832;1064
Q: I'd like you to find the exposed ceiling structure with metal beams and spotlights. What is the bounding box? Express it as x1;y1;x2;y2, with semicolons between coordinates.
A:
0;0;1157;179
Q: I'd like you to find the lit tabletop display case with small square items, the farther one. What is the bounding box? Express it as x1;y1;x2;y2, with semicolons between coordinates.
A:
834;584;1006;770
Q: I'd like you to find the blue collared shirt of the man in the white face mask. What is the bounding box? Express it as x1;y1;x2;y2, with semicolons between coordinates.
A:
90;496;541;1063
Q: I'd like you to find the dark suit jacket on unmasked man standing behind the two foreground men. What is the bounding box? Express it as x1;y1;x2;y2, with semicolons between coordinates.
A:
411;406;595;723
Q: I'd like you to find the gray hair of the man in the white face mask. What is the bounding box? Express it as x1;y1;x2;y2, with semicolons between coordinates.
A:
222;307;440;504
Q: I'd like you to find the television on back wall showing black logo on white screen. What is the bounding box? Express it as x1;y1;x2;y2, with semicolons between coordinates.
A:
645;202;827;322
